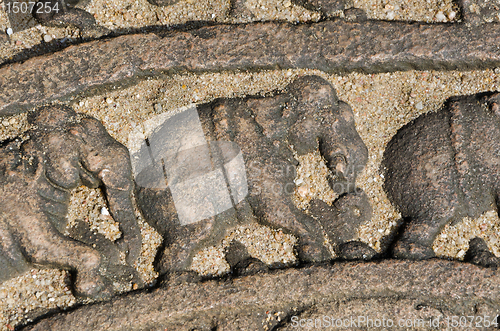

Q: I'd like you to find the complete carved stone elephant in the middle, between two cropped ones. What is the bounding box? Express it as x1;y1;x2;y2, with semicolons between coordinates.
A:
132;76;374;273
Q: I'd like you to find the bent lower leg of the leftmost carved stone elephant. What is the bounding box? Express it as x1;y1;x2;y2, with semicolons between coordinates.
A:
16;213;112;299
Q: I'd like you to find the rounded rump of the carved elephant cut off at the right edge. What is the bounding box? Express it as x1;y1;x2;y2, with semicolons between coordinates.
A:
383;93;500;259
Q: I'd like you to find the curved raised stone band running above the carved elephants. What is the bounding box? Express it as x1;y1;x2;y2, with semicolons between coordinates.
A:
0;20;500;116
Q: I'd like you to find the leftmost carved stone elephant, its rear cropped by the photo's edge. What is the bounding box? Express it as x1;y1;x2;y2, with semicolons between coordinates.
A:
0;106;142;299
